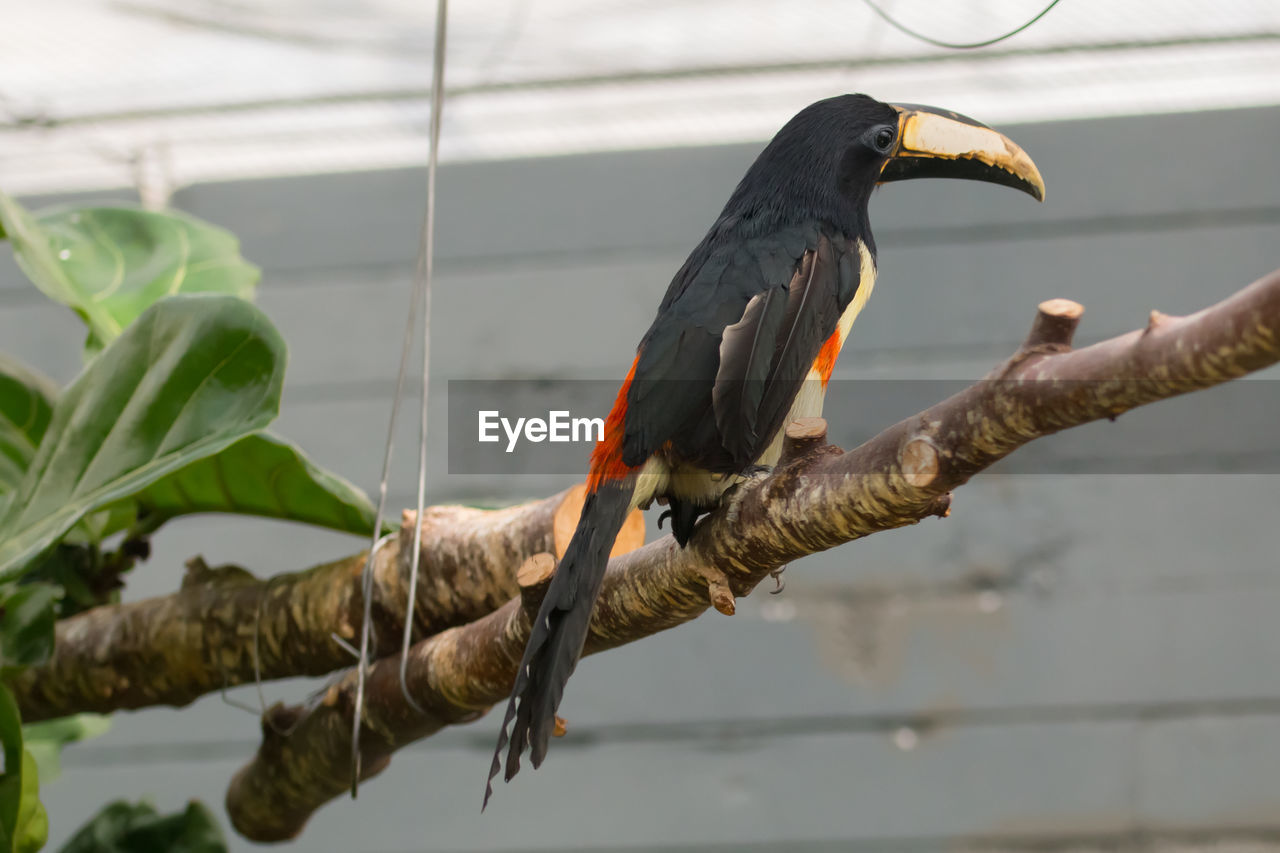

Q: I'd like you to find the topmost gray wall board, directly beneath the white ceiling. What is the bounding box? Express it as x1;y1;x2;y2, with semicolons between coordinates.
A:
0;108;1280;288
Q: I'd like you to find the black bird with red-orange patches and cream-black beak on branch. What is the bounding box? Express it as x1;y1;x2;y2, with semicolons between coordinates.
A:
485;95;1044;802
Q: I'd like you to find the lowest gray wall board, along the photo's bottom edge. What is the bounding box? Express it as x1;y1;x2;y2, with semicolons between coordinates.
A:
42;716;1280;853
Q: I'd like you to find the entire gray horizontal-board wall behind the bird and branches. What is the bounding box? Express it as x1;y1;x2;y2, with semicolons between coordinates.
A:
0;109;1280;852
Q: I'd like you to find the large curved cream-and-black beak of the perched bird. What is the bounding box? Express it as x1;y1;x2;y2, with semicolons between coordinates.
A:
879;104;1044;201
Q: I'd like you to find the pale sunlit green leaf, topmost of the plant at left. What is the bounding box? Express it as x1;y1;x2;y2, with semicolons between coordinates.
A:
0;196;261;352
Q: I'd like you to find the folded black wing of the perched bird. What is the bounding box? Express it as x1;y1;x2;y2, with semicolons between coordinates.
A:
623;223;859;471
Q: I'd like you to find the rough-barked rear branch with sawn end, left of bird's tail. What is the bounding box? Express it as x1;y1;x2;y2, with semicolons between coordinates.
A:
10;492;576;722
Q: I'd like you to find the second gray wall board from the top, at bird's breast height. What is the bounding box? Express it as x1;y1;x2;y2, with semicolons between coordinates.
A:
0;216;1280;396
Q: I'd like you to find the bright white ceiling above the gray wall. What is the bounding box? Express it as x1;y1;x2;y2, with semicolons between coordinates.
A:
0;0;1280;193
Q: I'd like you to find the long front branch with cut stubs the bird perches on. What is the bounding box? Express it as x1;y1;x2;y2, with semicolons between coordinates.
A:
227;270;1280;840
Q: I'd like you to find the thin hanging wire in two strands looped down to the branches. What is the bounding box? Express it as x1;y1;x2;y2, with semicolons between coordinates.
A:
351;0;448;799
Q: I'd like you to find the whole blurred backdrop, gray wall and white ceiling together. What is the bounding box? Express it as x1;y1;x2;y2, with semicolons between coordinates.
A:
0;0;1280;853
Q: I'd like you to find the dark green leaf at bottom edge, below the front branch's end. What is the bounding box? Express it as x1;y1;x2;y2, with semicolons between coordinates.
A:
61;800;227;853
